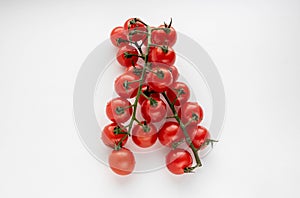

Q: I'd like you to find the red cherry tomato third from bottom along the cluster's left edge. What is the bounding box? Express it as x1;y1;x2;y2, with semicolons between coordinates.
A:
106;98;132;124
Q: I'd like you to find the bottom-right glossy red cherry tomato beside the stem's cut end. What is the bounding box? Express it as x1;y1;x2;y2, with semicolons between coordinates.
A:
166;148;193;175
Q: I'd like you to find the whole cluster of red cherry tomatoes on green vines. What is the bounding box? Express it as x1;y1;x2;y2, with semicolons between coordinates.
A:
102;18;212;175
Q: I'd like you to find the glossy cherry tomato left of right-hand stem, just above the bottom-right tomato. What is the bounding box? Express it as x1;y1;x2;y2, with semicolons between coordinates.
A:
158;121;184;147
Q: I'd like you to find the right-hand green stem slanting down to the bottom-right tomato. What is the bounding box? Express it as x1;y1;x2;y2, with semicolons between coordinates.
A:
162;93;202;172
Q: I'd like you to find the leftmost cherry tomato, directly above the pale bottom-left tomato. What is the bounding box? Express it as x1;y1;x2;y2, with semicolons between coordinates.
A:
101;123;128;148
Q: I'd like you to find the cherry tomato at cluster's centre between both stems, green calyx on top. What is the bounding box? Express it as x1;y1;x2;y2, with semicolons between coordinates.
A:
141;97;167;123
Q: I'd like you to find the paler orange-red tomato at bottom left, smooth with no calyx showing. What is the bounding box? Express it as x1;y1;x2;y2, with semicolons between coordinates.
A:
108;147;135;175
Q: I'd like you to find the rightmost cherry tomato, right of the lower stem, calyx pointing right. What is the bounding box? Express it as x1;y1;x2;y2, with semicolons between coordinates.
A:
187;126;210;149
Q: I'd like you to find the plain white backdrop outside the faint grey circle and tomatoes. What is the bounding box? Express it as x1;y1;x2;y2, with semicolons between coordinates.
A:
0;0;300;198
